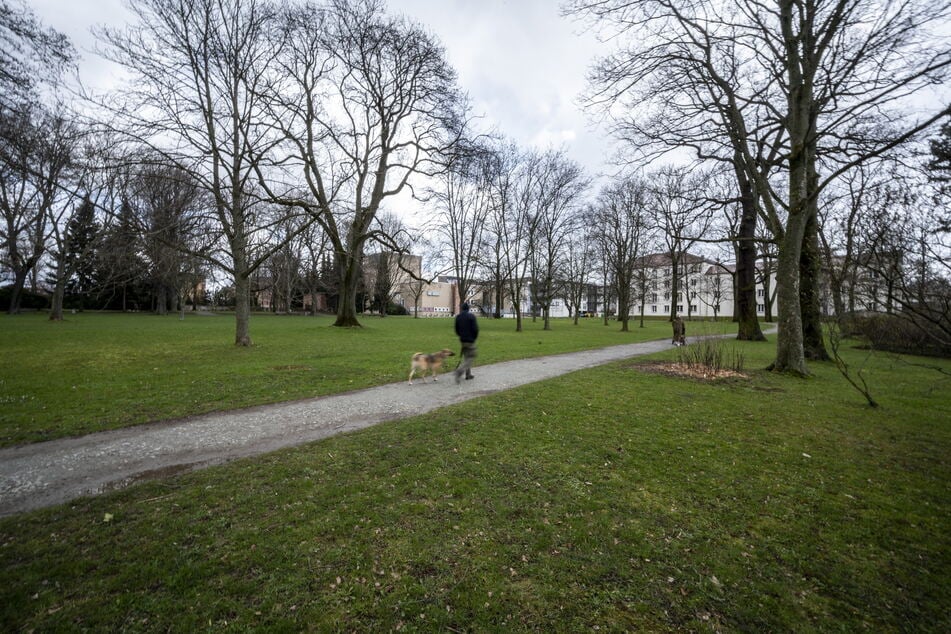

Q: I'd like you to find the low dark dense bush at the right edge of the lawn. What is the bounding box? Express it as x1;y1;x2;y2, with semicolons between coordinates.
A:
847;313;951;357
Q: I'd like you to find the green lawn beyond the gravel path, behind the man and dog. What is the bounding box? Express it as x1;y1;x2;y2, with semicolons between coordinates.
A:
0;313;712;447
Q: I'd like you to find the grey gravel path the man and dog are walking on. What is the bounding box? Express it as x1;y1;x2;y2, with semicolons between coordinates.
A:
0;334;700;516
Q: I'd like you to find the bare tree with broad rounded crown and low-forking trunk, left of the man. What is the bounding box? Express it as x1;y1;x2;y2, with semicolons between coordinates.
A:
262;0;461;327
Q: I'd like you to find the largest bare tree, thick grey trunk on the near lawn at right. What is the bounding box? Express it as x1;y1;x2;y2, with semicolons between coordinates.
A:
569;0;951;375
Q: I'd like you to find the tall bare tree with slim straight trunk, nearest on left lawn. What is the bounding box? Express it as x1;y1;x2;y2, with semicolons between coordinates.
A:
98;0;304;346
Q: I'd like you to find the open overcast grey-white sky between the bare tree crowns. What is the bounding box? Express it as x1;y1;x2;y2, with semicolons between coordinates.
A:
27;0;610;175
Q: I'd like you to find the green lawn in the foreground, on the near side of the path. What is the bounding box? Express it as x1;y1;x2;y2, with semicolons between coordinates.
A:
0;342;951;632
